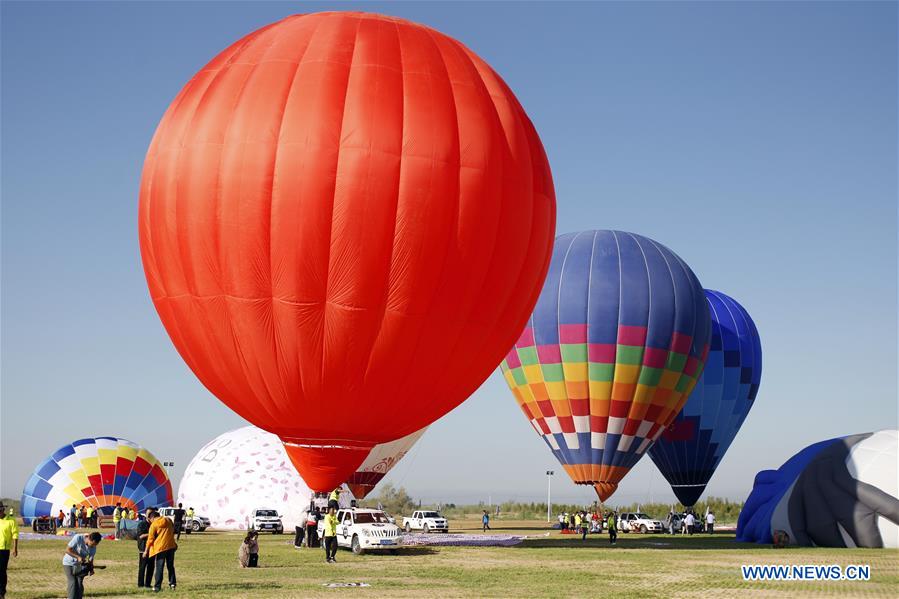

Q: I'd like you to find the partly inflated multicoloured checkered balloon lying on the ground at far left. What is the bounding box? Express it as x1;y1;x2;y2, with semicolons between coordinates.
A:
21;437;172;523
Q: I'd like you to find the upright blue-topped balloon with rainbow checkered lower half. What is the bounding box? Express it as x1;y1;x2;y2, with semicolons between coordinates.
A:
501;231;711;501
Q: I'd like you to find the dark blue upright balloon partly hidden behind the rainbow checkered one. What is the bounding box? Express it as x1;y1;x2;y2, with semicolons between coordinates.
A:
649;289;762;506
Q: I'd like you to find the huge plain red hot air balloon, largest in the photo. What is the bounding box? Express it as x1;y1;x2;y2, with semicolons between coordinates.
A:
139;13;555;490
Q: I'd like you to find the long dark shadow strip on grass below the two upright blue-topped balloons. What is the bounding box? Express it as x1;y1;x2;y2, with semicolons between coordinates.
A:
515;535;765;551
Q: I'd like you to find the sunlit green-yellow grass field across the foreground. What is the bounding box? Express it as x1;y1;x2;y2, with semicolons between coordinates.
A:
7;520;899;599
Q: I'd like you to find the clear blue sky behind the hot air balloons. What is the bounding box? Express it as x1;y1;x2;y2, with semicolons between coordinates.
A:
0;2;897;510
